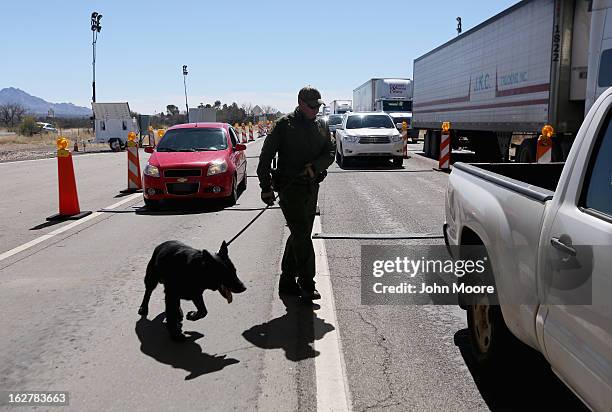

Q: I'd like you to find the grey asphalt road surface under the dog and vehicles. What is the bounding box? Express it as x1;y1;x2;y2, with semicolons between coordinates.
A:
0;140;582;411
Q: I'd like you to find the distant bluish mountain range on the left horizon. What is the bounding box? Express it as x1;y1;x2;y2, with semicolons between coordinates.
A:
0;87;92;117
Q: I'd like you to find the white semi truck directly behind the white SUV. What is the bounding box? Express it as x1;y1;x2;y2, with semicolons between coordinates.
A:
353;79;412;113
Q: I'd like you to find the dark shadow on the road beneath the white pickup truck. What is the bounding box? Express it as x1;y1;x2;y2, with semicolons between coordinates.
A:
454;329;588;411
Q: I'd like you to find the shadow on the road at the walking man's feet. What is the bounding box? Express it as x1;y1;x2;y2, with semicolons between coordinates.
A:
242;296;334;362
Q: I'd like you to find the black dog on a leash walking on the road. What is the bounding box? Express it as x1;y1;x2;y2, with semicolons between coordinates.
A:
138;240;246;341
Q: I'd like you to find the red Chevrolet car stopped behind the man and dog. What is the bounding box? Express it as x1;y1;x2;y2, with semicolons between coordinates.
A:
143;123;247;209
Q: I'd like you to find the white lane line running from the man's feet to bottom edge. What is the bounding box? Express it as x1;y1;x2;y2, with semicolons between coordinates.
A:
312;217;351;411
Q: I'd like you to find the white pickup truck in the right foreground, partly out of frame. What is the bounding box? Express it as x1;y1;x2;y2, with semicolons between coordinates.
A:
444;88;612;411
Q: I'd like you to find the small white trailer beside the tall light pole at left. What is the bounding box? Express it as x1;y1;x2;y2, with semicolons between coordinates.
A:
91;102;139;151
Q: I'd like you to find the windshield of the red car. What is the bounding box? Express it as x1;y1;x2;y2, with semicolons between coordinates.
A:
157;128;227;152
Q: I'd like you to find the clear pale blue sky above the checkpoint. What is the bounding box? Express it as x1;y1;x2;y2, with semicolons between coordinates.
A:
0;0;516;114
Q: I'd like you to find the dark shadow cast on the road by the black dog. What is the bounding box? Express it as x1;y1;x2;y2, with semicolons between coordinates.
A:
135;312;240;380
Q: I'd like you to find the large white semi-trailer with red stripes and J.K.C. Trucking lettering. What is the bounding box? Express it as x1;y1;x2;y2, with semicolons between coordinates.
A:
412;0;612;162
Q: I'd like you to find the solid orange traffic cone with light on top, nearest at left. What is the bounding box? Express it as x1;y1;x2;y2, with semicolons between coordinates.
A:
47;137;91;220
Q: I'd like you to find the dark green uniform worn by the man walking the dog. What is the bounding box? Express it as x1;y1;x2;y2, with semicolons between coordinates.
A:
257;108;336;290
